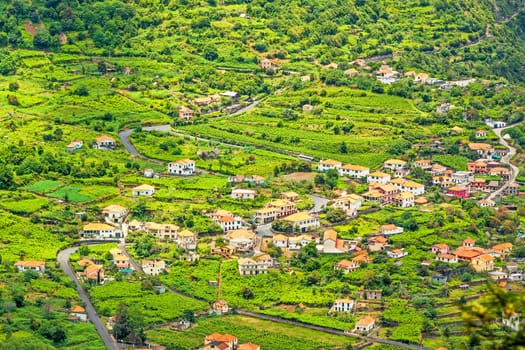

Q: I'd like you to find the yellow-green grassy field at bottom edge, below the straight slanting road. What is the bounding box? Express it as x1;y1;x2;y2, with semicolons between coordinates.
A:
147;316;355;350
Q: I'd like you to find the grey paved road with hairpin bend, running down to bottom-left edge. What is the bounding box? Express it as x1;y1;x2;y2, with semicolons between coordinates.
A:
57;247;118;350
